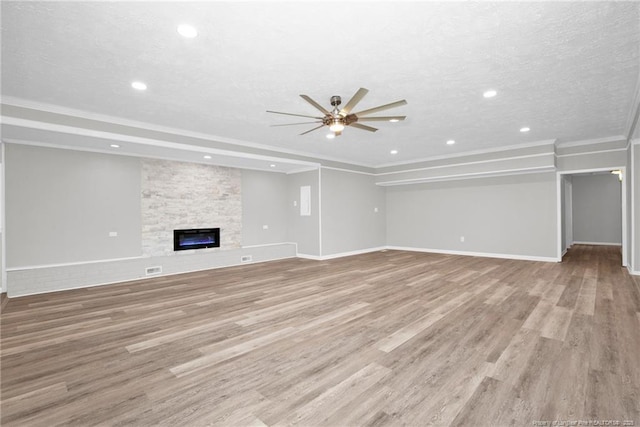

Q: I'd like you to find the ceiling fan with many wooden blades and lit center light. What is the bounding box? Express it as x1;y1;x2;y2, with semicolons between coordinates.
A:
267;88;407;137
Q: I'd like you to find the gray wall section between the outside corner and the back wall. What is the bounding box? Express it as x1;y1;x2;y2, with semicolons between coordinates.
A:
321;168;386;256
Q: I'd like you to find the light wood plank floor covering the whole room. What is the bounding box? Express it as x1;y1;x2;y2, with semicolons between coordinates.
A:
1;246;640;426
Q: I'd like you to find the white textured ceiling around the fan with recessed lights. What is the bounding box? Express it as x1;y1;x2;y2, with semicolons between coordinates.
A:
2;1;640;166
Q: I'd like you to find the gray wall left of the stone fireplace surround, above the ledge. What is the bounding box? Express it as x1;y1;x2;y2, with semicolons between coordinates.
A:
5;144;141;268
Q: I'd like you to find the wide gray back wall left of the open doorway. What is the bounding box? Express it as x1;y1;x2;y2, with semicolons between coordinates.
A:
387;173;557;258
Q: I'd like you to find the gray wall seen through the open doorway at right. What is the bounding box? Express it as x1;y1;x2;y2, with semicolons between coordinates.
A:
572;173;622;244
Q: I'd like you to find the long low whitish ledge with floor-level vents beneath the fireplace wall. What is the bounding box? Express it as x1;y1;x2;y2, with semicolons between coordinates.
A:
7;243;296;298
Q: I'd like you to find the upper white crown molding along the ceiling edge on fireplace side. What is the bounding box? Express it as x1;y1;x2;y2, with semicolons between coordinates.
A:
1;96;375;168
